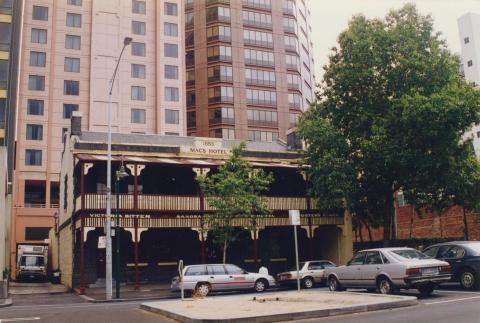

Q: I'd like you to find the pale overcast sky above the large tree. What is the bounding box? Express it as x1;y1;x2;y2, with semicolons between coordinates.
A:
310;0;480;81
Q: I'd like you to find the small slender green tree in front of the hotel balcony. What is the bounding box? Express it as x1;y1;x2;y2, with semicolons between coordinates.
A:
197;142;273;263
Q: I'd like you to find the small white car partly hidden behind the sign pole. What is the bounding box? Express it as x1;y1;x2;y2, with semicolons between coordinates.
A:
277;260;336;288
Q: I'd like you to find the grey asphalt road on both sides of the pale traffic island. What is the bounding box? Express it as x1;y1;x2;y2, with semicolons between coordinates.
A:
0;286;480;323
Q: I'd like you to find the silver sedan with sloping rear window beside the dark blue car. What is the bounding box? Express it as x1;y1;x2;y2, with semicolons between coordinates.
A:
325;248;451;296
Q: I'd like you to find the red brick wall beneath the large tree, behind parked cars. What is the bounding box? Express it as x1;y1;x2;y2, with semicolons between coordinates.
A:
353;205;480;242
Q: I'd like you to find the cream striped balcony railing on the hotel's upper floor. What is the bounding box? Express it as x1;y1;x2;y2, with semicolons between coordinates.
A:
76;193;315;211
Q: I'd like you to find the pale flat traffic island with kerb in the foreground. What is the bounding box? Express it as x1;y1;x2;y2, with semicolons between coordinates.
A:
140;290;418;323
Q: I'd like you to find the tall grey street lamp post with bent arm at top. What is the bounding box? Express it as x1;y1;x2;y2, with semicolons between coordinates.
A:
105;37;132;300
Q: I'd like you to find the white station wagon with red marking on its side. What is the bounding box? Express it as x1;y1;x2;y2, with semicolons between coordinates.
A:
171;264;275;296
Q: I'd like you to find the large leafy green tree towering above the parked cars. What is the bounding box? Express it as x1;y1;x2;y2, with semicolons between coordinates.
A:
299;5;480;245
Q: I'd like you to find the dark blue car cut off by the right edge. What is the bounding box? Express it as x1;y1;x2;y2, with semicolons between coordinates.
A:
424;241;480;290
